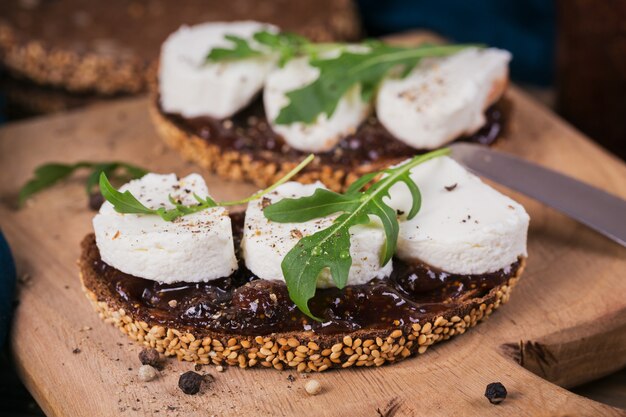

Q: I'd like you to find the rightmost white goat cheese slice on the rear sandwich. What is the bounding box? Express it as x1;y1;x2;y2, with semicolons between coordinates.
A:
376;48;511;149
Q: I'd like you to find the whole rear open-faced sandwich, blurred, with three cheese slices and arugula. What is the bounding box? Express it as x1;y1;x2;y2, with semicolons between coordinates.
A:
152;22;511;191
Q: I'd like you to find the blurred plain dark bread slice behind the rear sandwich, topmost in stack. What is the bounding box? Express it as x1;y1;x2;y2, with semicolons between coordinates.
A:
0;0;360;95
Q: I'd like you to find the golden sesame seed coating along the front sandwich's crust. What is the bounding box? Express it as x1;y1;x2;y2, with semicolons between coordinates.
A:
86;256;517;370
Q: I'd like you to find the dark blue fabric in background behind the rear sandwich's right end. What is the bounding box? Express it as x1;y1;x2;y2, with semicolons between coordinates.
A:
357;0;556;85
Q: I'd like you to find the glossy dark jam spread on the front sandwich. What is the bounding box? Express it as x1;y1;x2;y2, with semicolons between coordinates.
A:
89;213;519;335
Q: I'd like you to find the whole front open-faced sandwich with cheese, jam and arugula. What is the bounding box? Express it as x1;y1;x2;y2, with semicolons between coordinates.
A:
79;150;529;371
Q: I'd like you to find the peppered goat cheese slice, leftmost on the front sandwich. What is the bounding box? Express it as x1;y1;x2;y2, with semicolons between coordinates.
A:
93;174;237;283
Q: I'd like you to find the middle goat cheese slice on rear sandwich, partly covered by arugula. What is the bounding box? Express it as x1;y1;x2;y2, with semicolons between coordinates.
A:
263;58;371;152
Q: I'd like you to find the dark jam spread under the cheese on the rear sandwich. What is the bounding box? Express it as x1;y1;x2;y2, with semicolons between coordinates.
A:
165;99;510;167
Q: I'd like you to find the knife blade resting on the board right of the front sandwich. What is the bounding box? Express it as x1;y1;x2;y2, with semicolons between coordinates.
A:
450;143;626;247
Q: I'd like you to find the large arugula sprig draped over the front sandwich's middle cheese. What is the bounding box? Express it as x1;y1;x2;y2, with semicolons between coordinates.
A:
263;148;450;320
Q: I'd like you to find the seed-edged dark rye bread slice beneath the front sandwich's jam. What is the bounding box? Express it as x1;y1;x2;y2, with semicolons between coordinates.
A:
78;234;525;372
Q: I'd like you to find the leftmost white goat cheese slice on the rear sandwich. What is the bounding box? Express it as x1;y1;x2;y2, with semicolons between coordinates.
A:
159;21;278;119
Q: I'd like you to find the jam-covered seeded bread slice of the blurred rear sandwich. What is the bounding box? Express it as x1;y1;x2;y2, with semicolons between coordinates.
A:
150;96;511;191
